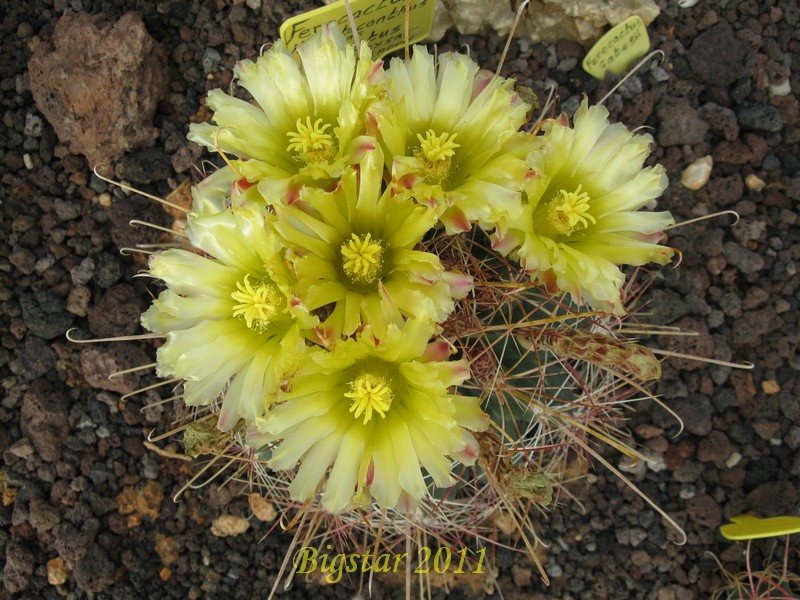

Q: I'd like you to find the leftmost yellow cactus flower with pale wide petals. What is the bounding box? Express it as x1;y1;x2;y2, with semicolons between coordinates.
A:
142;206;317;431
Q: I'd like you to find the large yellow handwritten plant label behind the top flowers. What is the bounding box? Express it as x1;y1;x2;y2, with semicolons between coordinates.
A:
281;0;436;58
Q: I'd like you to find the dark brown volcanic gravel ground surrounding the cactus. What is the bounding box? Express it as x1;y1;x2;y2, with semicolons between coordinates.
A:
0;0;800;600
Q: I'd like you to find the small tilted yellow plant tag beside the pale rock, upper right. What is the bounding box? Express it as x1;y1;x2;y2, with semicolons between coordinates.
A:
582;15;650;79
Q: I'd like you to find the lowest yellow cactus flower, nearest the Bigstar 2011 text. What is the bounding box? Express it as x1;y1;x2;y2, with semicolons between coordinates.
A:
257;319;489;513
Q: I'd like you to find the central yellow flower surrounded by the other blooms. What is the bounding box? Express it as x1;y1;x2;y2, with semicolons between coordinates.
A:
275;149;472;344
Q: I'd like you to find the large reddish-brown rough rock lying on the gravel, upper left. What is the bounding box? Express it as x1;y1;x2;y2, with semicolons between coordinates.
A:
28;10;167;165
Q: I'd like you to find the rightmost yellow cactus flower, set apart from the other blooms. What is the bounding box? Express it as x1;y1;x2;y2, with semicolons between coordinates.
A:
493;98;674;313
